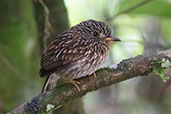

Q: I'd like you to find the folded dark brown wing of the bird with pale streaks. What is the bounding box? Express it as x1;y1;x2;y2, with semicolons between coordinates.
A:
40;32;87;76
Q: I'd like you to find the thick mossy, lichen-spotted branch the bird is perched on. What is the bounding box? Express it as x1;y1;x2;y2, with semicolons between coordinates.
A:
11;49;171;114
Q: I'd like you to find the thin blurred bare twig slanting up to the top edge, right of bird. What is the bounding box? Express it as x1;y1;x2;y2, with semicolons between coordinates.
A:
105;0;153;22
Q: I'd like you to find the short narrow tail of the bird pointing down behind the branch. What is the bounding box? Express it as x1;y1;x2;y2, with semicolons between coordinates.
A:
41;73;59;93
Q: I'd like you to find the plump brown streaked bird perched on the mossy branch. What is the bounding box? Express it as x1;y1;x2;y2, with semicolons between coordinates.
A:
39;19;121;93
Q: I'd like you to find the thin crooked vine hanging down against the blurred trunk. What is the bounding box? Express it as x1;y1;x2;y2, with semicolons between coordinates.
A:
39;0;51;48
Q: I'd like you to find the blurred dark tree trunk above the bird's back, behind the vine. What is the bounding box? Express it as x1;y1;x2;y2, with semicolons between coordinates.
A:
34;0;69;43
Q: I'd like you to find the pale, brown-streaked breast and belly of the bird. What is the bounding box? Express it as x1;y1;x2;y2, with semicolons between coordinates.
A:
56;40;109;79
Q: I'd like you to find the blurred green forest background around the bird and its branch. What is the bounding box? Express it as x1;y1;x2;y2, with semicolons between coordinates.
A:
0;0;171;114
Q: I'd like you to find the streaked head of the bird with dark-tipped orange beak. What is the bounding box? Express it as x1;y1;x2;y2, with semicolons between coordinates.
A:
80;20;121;44
